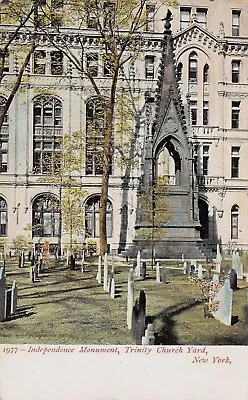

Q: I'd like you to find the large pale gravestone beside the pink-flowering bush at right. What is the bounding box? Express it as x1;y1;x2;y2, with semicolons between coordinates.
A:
213;279;233;326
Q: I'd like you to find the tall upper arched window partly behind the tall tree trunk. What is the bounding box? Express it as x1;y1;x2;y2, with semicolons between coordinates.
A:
86;98;112;175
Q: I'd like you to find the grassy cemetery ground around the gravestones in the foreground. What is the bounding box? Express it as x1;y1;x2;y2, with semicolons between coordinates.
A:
0;258;248;345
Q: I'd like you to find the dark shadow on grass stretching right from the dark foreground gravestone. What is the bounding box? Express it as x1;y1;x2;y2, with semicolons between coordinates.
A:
146;298;202;345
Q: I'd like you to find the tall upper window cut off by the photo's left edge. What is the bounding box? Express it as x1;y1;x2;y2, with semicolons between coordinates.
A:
0;96;9;172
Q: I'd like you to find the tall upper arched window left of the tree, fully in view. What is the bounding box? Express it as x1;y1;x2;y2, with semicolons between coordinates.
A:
33;96;63;174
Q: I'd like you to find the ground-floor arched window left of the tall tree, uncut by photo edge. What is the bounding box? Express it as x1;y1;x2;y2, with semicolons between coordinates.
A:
32;194;60;237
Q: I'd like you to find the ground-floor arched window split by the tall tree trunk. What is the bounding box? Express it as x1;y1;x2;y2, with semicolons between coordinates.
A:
85;196;113;237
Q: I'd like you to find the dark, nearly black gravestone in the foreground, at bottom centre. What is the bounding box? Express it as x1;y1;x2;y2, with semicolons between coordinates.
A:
132;290;146;344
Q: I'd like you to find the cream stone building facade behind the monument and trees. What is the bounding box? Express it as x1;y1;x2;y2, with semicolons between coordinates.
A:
0;0;248;252
